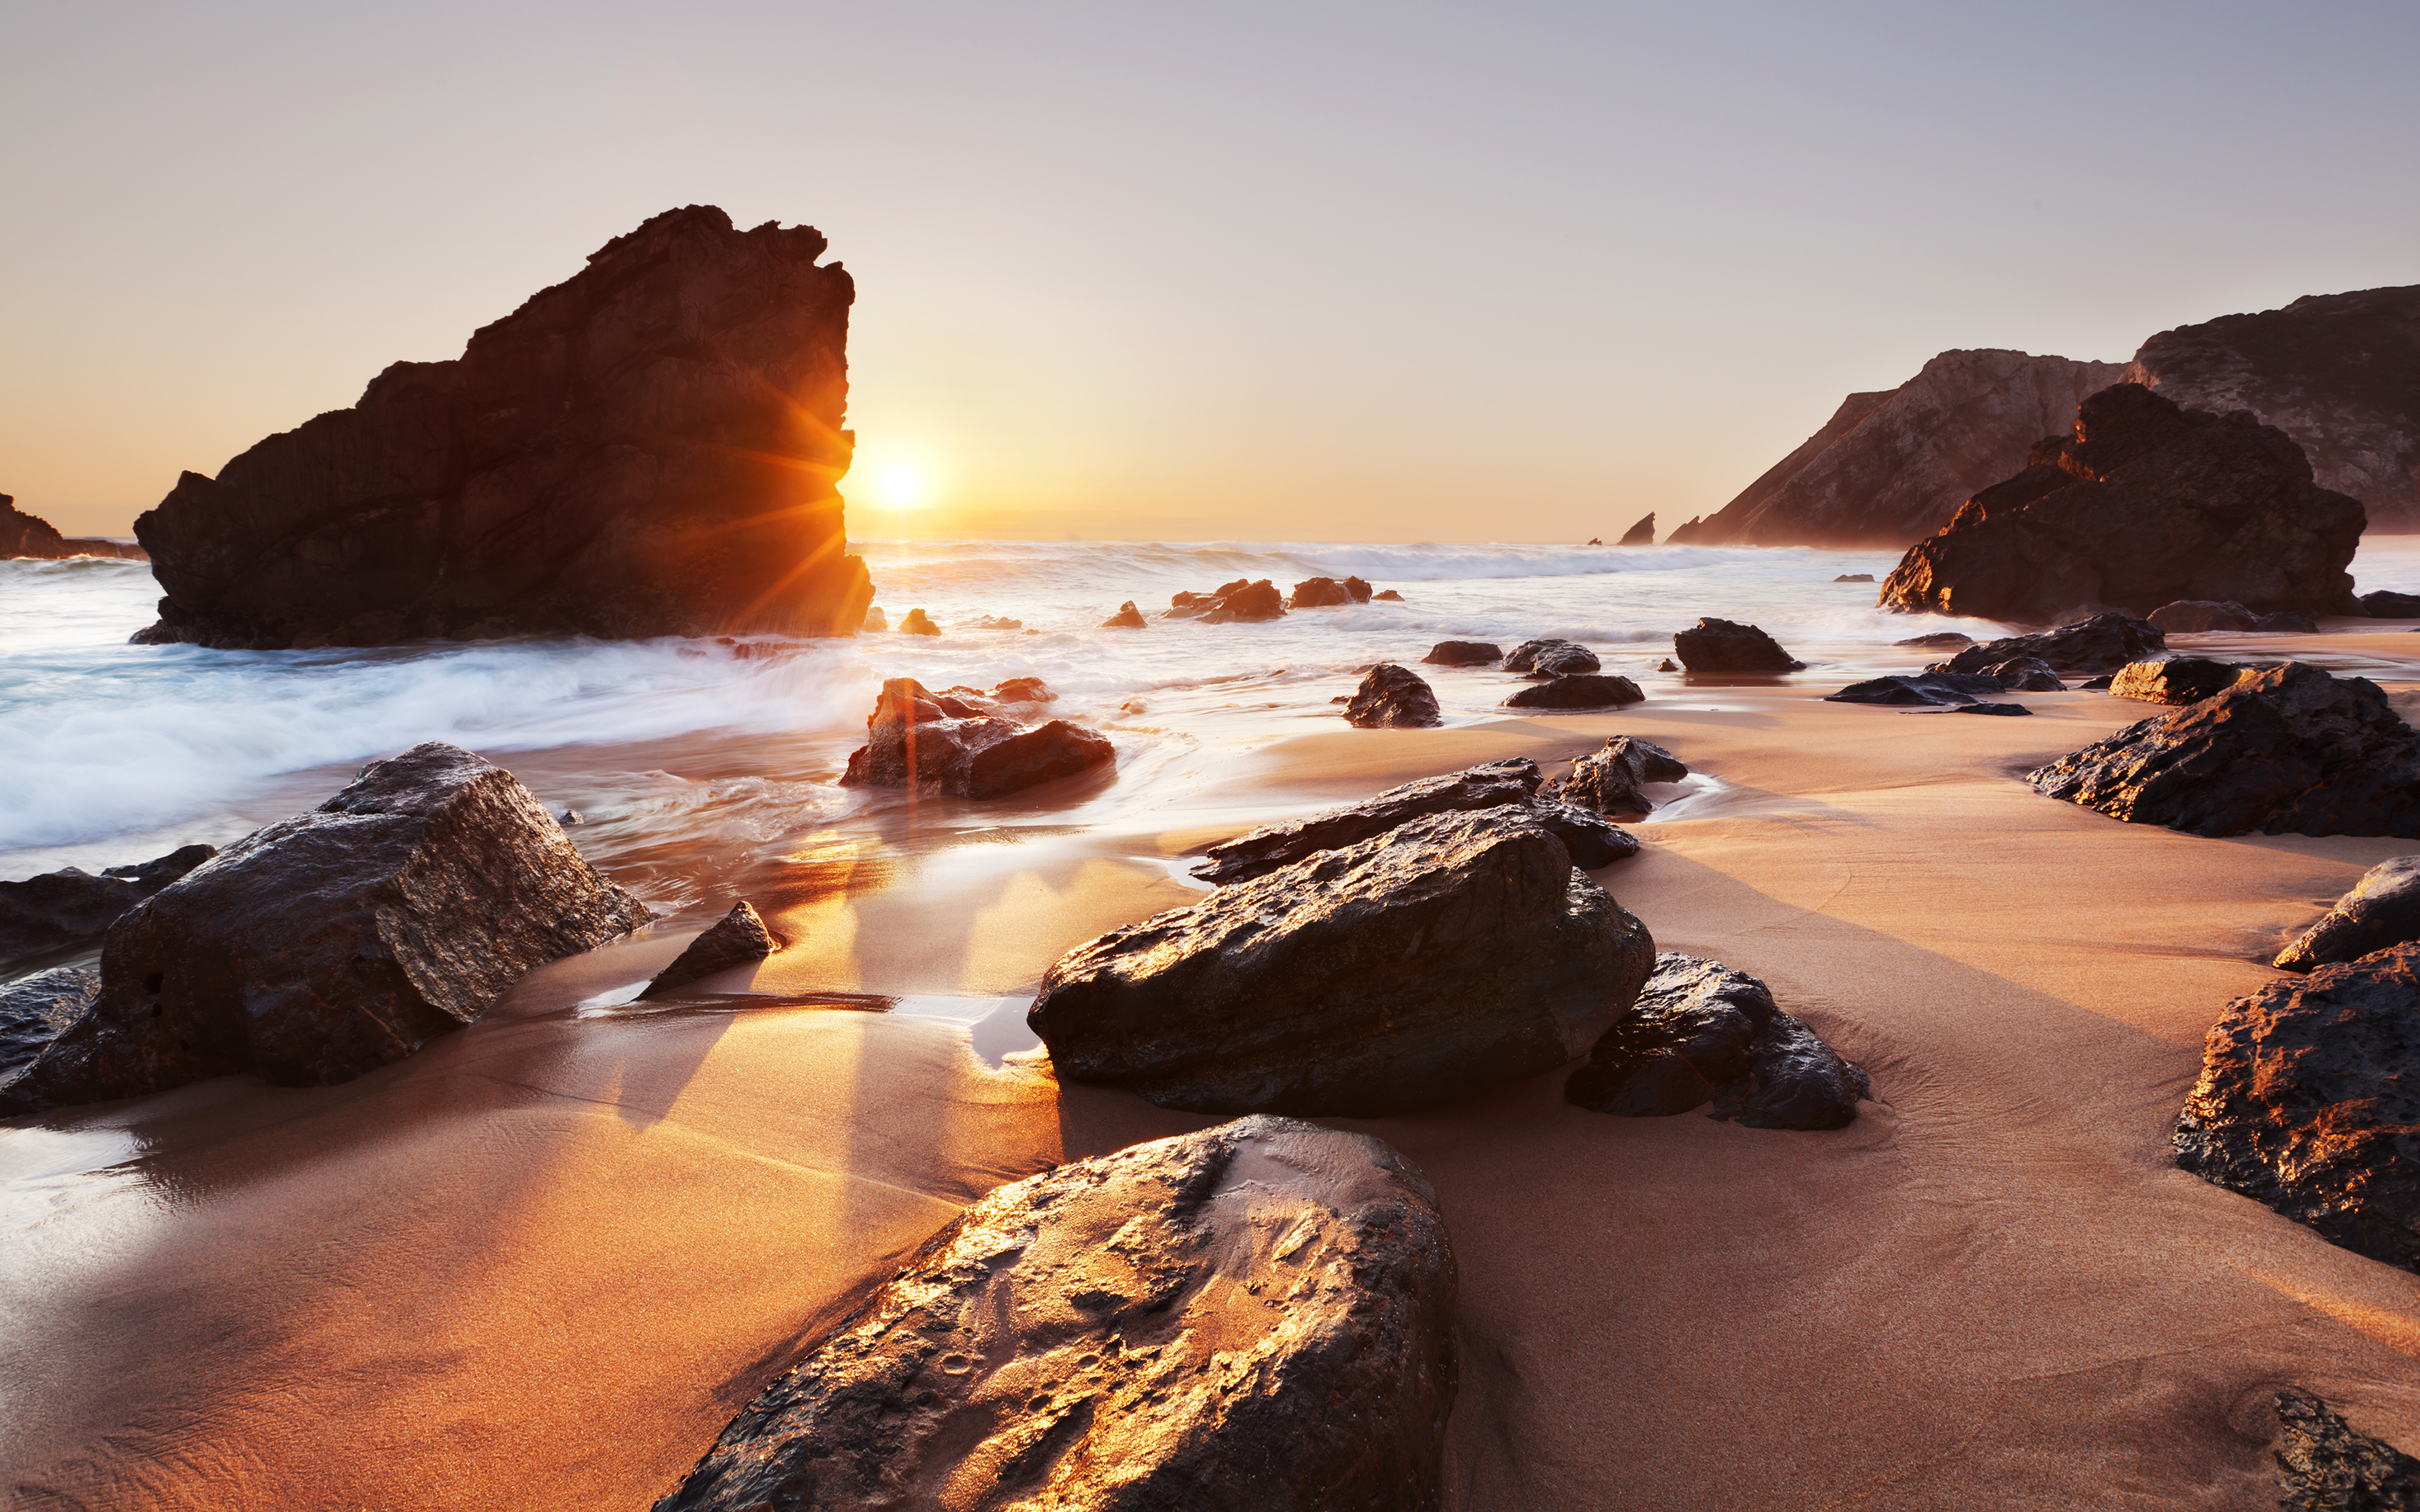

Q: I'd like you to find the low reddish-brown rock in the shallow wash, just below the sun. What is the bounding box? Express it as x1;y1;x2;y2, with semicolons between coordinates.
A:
840;677;1118;798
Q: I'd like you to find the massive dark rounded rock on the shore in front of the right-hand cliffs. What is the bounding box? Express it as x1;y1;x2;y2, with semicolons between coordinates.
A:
1878;382;2364;624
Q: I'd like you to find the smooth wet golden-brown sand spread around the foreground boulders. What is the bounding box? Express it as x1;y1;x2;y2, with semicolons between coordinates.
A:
0;648;2420;1512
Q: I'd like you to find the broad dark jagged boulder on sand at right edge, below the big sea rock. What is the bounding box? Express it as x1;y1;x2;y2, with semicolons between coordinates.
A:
2026;661;2420;837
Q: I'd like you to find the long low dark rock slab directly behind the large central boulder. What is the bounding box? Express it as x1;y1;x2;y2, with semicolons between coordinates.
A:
1193;757;1638;885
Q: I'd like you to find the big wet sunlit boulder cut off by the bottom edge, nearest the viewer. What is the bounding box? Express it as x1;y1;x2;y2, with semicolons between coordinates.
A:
656;1118;1457;1512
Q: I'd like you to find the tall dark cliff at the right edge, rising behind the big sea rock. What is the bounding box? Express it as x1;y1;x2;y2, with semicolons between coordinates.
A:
2127;286;2420;532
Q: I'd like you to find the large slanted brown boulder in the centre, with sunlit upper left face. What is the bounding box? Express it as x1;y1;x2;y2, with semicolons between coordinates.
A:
1026;808;1655;1118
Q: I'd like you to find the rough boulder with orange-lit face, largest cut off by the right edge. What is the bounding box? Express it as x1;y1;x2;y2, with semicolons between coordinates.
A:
2176;946;2420;1270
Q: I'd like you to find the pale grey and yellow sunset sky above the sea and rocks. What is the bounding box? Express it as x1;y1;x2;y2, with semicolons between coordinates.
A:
0;0;2420;542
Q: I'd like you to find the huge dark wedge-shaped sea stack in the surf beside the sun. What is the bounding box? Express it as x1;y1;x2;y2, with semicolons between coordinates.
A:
122;206;871;648
